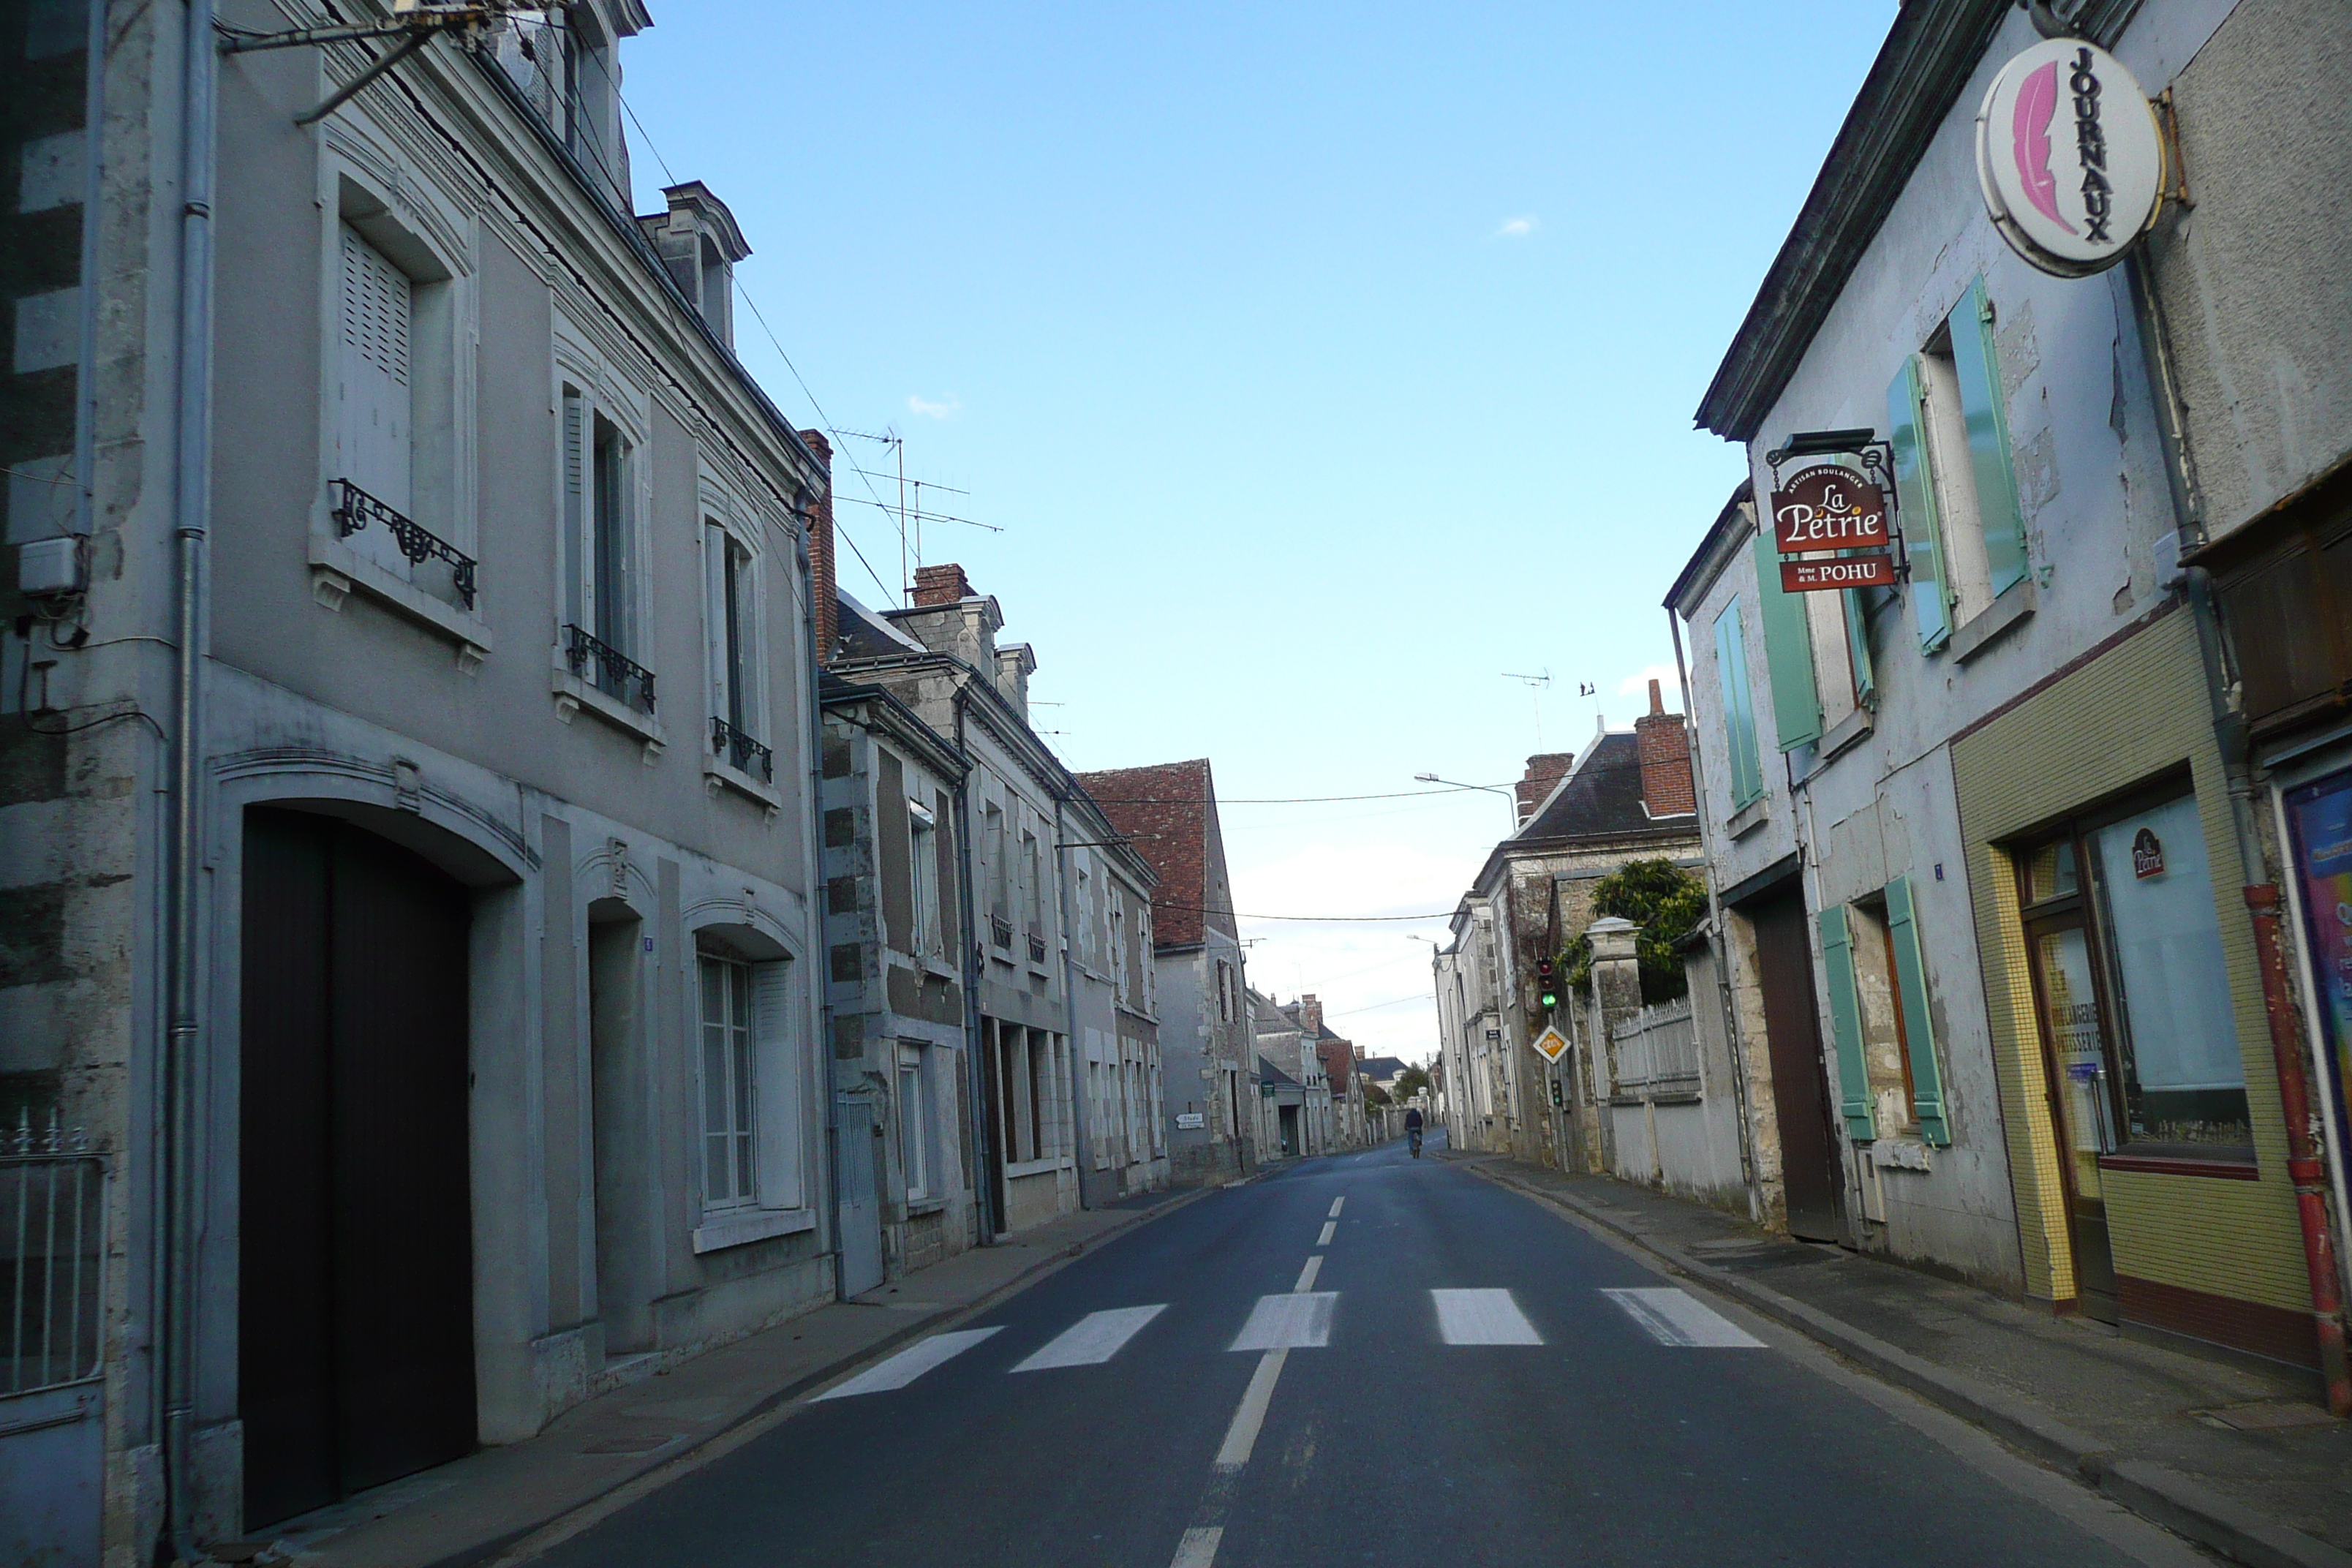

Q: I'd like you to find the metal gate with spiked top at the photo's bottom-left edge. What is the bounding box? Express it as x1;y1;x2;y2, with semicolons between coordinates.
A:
0;1112;106;1568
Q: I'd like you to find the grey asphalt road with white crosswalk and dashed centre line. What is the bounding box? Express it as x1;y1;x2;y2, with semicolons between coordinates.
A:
524;1142;2209;1568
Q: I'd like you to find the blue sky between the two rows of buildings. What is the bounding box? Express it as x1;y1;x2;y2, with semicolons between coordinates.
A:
623;0;1896;1058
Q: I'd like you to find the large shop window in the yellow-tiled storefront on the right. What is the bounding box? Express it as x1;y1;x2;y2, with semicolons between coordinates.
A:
2021;794;2253;1169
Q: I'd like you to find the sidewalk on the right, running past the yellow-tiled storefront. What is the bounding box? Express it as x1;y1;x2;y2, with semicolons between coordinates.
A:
1439;1152;2352;1568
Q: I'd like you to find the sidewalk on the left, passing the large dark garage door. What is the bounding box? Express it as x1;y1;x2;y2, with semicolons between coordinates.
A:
238;1187;1216;1568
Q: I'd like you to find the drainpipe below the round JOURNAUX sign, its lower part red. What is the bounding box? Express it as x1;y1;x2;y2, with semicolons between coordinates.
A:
2124;249;2352;1417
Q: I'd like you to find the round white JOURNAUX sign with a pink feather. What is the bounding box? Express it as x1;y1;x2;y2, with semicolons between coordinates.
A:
1975;37;2164;277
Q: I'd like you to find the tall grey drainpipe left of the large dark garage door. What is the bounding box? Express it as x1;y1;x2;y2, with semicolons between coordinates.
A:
155;0;219;1564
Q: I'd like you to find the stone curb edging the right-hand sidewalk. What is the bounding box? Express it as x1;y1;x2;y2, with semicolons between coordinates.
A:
1463;1161;2352;1568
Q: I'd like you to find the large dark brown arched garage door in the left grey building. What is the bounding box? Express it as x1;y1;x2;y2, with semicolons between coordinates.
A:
238;809;475;1526
